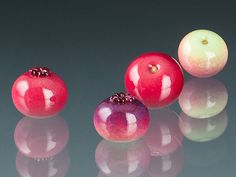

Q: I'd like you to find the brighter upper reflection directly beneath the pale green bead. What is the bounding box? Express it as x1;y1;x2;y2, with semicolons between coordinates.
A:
179;78;228;119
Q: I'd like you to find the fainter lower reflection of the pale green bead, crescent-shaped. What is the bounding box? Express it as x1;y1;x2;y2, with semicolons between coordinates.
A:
179;111;228;142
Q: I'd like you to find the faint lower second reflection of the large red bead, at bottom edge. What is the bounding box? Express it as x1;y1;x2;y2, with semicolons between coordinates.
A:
148;148;184;177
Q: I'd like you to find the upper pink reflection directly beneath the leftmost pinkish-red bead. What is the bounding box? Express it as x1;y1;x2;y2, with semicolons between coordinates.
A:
14;117;69;158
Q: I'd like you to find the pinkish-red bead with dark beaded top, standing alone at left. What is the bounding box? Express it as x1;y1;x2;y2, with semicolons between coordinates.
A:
12;67;68;118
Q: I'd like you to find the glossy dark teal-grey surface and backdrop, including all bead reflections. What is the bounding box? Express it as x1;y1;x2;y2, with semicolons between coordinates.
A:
0;0;236;177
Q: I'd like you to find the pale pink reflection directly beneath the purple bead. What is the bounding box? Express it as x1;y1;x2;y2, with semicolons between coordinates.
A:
95;140;150;177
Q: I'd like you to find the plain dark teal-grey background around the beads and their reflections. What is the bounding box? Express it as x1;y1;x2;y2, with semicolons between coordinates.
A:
0;0;236;177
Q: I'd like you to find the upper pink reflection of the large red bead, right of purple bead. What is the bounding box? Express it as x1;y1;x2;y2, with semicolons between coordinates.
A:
144;109;183;156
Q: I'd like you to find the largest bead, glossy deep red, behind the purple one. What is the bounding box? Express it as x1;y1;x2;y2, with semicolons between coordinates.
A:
125;52;184;108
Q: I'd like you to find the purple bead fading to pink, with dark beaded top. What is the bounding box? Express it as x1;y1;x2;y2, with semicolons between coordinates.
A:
94;92;150;142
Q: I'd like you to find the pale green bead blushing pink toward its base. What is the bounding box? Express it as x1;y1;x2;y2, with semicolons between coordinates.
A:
178;29;228;77
